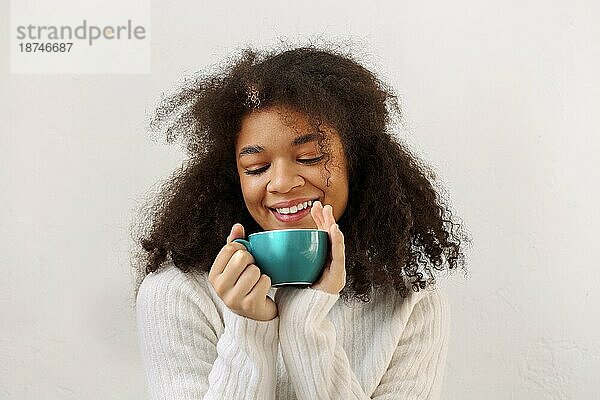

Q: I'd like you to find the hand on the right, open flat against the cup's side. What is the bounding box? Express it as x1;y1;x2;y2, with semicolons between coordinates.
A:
310;201;346;294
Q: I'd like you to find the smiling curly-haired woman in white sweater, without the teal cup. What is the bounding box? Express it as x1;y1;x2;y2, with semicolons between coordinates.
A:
137;47;468;400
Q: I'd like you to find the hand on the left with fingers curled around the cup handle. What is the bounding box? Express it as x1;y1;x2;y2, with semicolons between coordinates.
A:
208;224;277;321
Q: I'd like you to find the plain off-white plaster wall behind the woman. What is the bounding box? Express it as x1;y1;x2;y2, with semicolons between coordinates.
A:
0;0;600;400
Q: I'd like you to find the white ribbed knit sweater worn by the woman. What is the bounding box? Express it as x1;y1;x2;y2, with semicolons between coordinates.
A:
137;263;450;400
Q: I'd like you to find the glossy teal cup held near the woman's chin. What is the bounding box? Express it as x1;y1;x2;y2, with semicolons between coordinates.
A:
233;229;329;287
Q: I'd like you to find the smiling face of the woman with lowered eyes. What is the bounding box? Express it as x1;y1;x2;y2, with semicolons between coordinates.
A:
235;107;348;230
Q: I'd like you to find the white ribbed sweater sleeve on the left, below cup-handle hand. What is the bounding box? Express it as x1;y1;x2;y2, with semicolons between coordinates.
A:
136;271;279;400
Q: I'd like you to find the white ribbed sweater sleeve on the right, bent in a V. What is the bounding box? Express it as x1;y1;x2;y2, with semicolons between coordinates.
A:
276;288;449;400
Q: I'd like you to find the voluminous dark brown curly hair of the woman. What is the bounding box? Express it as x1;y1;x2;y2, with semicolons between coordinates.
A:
134;45;470;302
